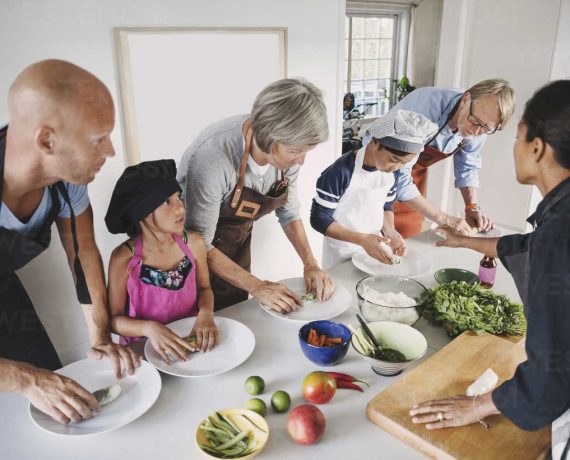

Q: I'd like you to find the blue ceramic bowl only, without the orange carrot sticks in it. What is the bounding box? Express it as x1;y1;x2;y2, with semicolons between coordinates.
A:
299;320;352;366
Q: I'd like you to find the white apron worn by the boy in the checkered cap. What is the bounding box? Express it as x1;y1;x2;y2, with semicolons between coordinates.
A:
323;147;395;270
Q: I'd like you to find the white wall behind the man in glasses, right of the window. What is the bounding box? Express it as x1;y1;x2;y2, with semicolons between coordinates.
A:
428;0;568;230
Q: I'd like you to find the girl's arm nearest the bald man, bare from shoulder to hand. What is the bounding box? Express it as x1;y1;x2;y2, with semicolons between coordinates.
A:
107;244;194;363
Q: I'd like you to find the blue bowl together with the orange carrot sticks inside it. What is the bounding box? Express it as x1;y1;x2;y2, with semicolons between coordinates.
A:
299;320;352;366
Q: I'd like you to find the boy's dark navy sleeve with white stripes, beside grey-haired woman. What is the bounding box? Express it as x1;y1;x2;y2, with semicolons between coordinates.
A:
311;152;356;235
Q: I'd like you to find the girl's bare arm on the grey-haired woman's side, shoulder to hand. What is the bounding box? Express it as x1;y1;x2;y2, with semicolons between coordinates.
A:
188;232;218;351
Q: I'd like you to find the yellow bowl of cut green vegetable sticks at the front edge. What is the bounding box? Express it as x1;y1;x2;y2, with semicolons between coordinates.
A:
196;409;269;460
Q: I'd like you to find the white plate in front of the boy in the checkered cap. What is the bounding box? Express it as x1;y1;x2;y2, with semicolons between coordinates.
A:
352;249;431;277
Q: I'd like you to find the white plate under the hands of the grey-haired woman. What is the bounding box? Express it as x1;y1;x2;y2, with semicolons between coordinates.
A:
259;278;352;323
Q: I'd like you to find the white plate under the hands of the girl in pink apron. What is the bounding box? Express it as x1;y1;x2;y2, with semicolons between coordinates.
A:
144;316;255;377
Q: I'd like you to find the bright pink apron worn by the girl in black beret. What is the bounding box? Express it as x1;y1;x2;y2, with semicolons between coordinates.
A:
120;234;198;345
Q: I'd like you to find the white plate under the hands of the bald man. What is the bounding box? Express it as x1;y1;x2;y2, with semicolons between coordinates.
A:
29;359;162;436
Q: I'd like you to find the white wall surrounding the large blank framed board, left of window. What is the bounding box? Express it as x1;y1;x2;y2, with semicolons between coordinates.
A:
0;0;344;362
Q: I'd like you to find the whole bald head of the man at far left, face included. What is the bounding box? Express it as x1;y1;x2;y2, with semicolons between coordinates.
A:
8;59;115;184
